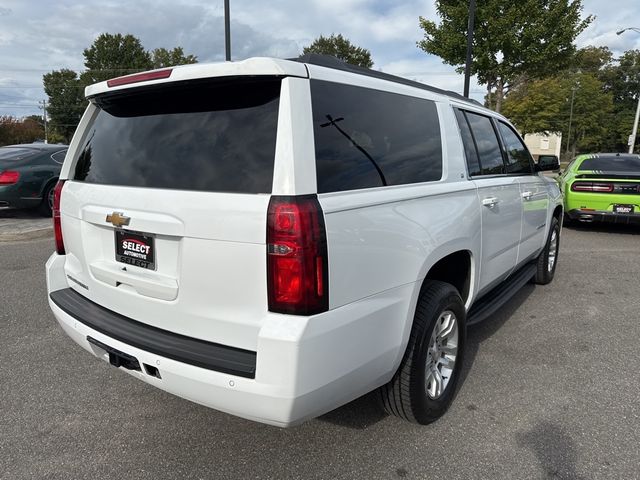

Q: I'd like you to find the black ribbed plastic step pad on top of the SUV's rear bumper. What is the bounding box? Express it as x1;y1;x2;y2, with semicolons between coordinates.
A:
49;288;257;378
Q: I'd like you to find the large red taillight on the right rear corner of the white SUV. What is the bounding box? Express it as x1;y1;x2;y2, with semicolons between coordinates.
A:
267;195;329;315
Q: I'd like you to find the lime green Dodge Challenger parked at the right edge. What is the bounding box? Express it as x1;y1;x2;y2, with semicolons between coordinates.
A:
559;153;640;223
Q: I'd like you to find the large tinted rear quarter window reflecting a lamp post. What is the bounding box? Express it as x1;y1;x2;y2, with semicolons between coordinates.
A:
311;80;442;193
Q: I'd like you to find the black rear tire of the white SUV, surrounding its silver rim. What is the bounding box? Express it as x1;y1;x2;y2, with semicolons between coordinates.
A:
378;280;466;425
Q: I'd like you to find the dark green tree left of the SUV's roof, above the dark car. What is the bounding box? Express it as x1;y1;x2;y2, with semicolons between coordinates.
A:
42;68;87;143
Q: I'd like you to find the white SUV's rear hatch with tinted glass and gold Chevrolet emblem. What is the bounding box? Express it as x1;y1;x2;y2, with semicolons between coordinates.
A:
61;76;281;350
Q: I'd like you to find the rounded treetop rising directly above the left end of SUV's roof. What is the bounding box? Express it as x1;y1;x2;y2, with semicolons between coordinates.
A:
82;33;153;85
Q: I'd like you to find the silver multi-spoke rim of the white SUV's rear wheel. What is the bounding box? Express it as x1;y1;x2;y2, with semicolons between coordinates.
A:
425;310;458;400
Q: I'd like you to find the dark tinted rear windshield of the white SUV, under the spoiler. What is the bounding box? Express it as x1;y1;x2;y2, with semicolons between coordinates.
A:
74;78;281;193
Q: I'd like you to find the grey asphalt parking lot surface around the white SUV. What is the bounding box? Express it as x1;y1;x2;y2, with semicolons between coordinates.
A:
0;226;640;479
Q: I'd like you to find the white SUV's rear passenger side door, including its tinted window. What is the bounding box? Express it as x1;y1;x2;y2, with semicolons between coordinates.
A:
456;110;522;295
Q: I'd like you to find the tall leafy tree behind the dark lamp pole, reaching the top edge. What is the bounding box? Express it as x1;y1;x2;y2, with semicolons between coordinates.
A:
418;0;593;112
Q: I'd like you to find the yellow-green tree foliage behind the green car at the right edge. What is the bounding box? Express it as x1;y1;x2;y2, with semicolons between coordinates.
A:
503;46;640;152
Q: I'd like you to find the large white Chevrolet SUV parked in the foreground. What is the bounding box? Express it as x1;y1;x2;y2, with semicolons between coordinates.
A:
46;56;562;426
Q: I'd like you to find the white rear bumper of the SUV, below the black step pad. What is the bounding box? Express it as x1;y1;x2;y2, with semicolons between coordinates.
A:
47;254;414;427
